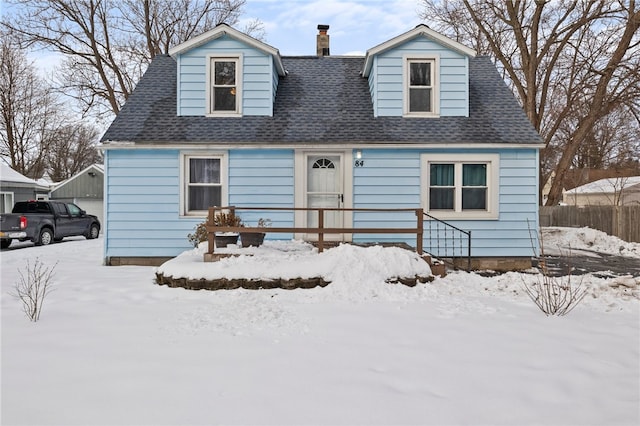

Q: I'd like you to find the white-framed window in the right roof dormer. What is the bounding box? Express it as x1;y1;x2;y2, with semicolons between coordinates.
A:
404;57;439;117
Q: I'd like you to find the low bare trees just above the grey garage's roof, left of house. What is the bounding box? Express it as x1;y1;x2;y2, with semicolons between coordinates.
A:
48;123;102;182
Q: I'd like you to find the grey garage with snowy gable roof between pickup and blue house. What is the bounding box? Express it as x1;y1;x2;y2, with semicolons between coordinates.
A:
50;164;104;223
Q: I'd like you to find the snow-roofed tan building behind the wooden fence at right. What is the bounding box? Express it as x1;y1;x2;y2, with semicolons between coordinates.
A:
562;176;640;206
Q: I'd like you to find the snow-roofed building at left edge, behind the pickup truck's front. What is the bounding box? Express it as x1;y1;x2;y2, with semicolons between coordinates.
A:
0;160;49;213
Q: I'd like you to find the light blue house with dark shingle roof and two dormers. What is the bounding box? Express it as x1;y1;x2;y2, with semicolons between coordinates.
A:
102;24;543;269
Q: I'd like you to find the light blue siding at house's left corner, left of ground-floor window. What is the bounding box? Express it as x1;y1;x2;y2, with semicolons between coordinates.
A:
105;150;202;257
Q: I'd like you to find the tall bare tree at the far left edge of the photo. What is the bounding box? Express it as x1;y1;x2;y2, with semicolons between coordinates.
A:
0;32;60;179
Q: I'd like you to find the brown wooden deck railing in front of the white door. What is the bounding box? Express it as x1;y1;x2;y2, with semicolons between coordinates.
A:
206;206;424;255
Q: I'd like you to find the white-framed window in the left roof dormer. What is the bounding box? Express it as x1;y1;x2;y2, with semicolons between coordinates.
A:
207;56;242;115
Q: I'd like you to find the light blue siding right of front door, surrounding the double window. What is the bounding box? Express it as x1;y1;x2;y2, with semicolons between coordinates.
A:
353;149;538;257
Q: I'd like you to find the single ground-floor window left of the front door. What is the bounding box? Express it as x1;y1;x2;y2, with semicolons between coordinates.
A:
183;155;226;216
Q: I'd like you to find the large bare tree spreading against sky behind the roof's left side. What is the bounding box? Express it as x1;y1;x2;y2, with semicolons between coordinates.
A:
4;0;260;117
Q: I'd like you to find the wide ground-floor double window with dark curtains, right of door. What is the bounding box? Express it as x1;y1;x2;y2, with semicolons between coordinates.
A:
423;154;499;219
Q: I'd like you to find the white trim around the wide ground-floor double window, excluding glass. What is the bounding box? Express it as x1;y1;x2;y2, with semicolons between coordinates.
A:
420;154;500;220
